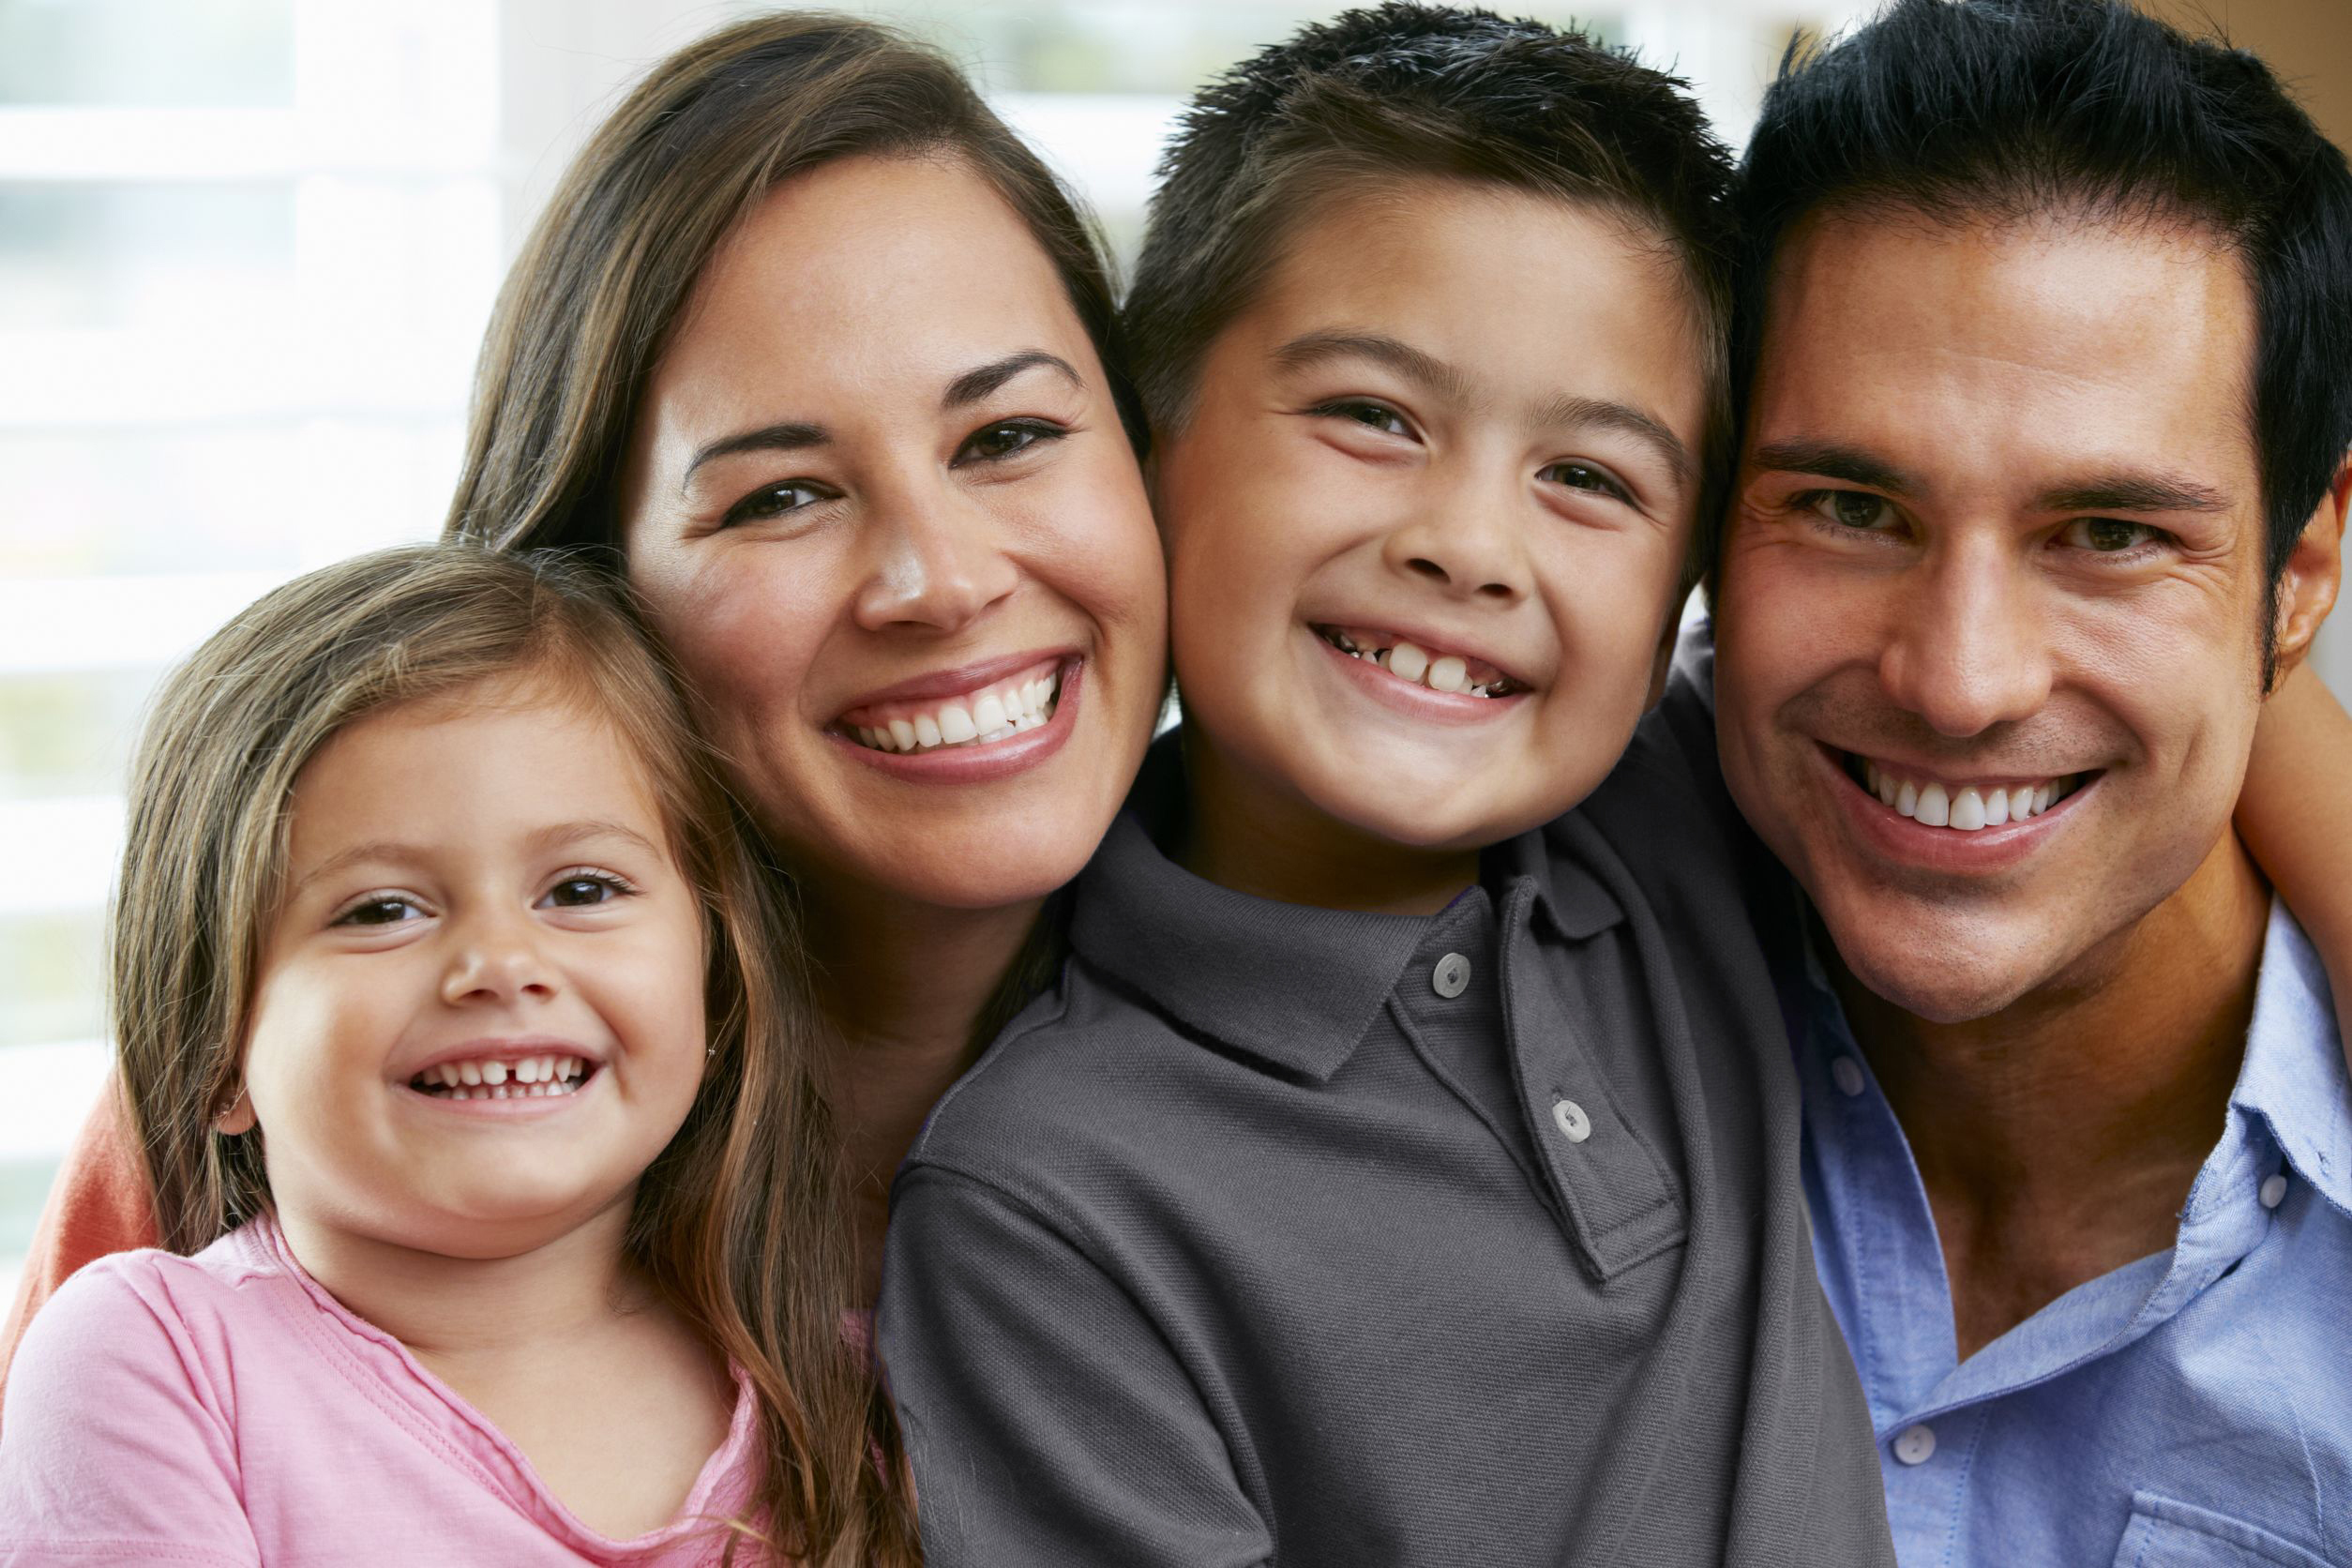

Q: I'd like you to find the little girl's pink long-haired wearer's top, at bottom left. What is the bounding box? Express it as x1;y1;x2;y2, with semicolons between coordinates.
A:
0;1220;758;1568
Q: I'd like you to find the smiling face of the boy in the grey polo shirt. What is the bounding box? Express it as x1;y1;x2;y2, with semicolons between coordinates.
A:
1154;179;1705;879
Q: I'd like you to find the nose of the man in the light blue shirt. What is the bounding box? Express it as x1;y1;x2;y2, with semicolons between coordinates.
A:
1879;538;2051;736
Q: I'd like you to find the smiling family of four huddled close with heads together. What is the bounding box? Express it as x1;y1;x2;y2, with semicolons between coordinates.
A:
0;0;2352;1568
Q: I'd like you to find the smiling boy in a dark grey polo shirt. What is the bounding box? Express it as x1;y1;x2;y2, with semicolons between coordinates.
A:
880;5;1893;1568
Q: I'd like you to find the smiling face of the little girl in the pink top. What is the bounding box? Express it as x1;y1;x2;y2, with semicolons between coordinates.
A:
223;682;703;1258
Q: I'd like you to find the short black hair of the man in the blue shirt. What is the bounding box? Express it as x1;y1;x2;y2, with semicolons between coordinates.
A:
1733;0;2352;629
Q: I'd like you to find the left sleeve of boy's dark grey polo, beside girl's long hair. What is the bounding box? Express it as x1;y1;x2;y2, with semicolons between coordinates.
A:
880;1166;1273;1568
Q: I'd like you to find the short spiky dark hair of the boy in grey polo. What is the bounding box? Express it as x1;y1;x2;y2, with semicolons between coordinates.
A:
1126;5;1731;524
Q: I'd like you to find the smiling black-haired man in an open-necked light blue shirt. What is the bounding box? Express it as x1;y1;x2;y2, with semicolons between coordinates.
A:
1714;0;2352;1563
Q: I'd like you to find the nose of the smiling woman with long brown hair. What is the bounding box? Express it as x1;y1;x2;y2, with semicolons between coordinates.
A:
853;475;1020;632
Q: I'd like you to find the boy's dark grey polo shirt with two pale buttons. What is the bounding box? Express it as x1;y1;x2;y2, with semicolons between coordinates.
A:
880;733;1893;1568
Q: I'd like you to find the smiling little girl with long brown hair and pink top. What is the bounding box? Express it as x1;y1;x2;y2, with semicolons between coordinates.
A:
0;548;917;1565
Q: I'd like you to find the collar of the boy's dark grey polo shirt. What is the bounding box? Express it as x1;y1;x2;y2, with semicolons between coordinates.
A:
1070;733;1621;1081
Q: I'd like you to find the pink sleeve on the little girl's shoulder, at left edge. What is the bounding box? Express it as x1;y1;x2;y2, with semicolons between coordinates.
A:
0;1253;261;1568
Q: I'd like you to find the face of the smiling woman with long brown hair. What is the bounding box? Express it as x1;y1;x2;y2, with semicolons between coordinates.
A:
621;158;1167;908
